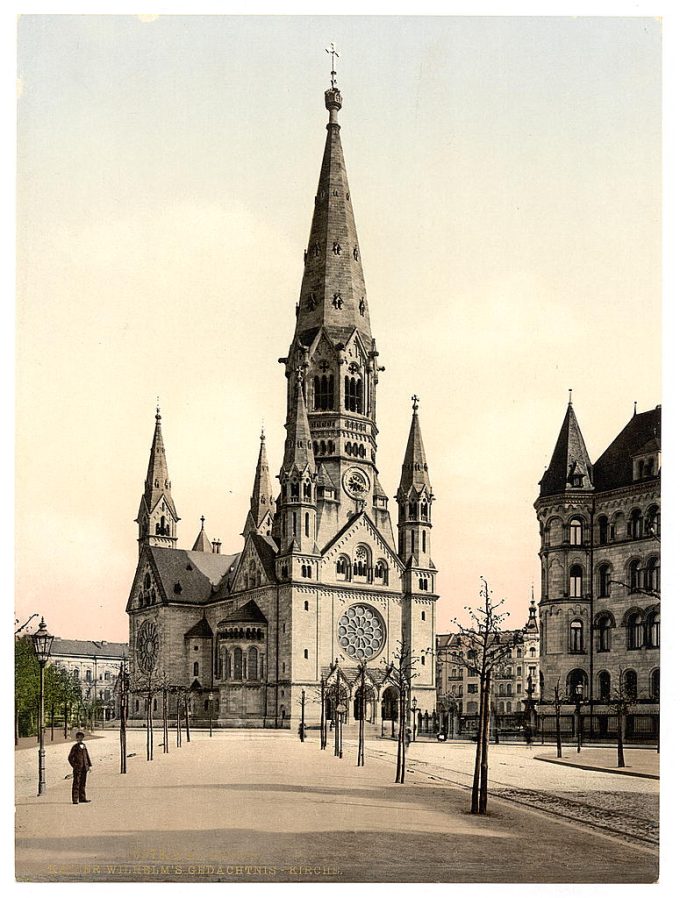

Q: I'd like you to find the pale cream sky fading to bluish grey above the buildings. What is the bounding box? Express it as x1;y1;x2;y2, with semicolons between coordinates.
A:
15;15;662;641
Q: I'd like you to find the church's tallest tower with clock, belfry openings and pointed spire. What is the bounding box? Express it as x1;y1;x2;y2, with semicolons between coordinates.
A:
280;79;394;546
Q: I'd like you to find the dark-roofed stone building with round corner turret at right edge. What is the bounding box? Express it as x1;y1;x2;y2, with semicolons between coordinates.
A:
534;401;661;736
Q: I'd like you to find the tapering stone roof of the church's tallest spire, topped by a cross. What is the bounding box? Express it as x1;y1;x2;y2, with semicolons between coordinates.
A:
295;76;372;351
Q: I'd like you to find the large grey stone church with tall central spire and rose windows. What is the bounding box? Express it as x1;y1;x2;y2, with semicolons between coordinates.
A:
127;72;437;728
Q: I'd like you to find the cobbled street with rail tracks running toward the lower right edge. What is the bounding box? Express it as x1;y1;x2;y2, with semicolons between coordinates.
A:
369;741;659;845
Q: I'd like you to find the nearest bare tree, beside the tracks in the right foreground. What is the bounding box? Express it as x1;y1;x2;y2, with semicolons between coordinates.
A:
447;577;524;814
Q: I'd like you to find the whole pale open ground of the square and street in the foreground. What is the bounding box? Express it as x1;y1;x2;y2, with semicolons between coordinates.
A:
16;730;658;883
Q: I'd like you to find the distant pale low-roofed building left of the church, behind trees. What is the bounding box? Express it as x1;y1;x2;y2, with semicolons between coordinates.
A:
50;636;128;720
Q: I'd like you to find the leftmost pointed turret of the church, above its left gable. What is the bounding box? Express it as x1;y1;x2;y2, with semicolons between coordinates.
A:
135;406;180;551
